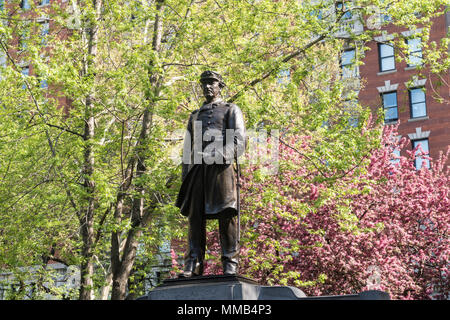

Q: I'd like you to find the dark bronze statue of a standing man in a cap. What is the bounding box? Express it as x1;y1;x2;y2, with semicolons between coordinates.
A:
176;71;245;277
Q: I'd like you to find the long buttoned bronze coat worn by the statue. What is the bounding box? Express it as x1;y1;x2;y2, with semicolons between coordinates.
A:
176;101;245;218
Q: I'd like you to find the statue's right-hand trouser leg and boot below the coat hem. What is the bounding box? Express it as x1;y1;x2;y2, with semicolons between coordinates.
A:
219;212;239;275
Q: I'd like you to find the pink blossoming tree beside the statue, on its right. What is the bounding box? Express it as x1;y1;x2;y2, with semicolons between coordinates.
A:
200;127;450;299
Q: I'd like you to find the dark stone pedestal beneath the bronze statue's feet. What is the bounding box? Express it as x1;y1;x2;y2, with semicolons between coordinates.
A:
139;275;390;300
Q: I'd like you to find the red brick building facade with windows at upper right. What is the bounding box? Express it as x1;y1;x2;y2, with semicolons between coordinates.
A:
359;13;450;167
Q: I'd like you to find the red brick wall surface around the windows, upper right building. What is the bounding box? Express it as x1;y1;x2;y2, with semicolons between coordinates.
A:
359;15;450;164
